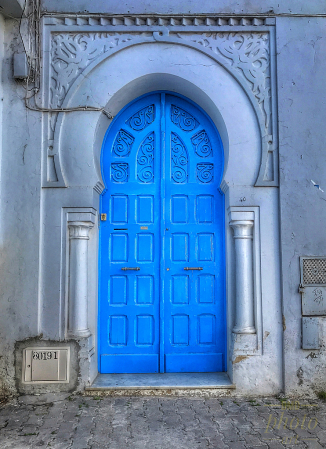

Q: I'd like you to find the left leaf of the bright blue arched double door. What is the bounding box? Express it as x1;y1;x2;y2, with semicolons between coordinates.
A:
99;95;160;373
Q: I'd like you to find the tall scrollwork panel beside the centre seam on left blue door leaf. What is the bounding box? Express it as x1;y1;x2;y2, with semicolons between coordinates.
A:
137;132;155;183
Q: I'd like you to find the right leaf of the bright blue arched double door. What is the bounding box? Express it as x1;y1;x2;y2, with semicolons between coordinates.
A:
165;95;225;372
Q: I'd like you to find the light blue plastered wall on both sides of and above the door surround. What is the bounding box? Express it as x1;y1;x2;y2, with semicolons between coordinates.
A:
0;0;326;393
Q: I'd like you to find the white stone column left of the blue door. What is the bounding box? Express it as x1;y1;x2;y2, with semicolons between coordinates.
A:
68;221;93;338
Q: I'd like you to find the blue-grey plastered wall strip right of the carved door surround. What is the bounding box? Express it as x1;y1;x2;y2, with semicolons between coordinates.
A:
277;18;326;394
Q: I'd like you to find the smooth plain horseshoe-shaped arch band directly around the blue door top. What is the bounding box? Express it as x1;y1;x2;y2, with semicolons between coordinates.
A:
55;46;261;196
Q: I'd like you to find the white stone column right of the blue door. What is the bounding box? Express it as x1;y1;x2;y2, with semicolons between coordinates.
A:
230;212;256;334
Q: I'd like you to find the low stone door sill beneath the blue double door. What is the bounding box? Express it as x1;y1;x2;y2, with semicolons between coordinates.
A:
85;372;235;396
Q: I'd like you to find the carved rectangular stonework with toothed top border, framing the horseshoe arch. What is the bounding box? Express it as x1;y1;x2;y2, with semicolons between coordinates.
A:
45;16;277;186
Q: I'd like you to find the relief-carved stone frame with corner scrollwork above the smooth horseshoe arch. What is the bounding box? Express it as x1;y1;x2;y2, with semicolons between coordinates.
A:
44;17;278;187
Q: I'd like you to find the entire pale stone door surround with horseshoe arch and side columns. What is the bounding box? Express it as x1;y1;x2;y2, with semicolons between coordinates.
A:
38;16;279;391
